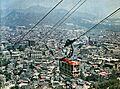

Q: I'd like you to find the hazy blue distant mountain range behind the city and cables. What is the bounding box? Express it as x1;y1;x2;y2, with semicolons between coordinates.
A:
0;6;120;31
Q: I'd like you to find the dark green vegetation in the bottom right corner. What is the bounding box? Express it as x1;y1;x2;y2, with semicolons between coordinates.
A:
86;70;120;89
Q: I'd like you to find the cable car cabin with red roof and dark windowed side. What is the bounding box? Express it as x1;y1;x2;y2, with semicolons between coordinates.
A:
59;58;80;78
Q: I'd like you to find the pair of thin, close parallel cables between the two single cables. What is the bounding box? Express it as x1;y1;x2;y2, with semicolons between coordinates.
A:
37;0;87;41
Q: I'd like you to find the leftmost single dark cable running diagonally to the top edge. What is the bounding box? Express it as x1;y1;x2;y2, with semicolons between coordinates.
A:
13;0;63;46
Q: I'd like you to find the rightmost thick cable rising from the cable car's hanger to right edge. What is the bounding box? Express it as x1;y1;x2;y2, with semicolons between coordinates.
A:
64;8;120;47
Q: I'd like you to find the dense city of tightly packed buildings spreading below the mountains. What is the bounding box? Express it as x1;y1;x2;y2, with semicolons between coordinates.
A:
0;22;120;89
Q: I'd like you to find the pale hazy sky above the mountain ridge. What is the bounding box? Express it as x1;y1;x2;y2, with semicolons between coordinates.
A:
0;0;120;17
